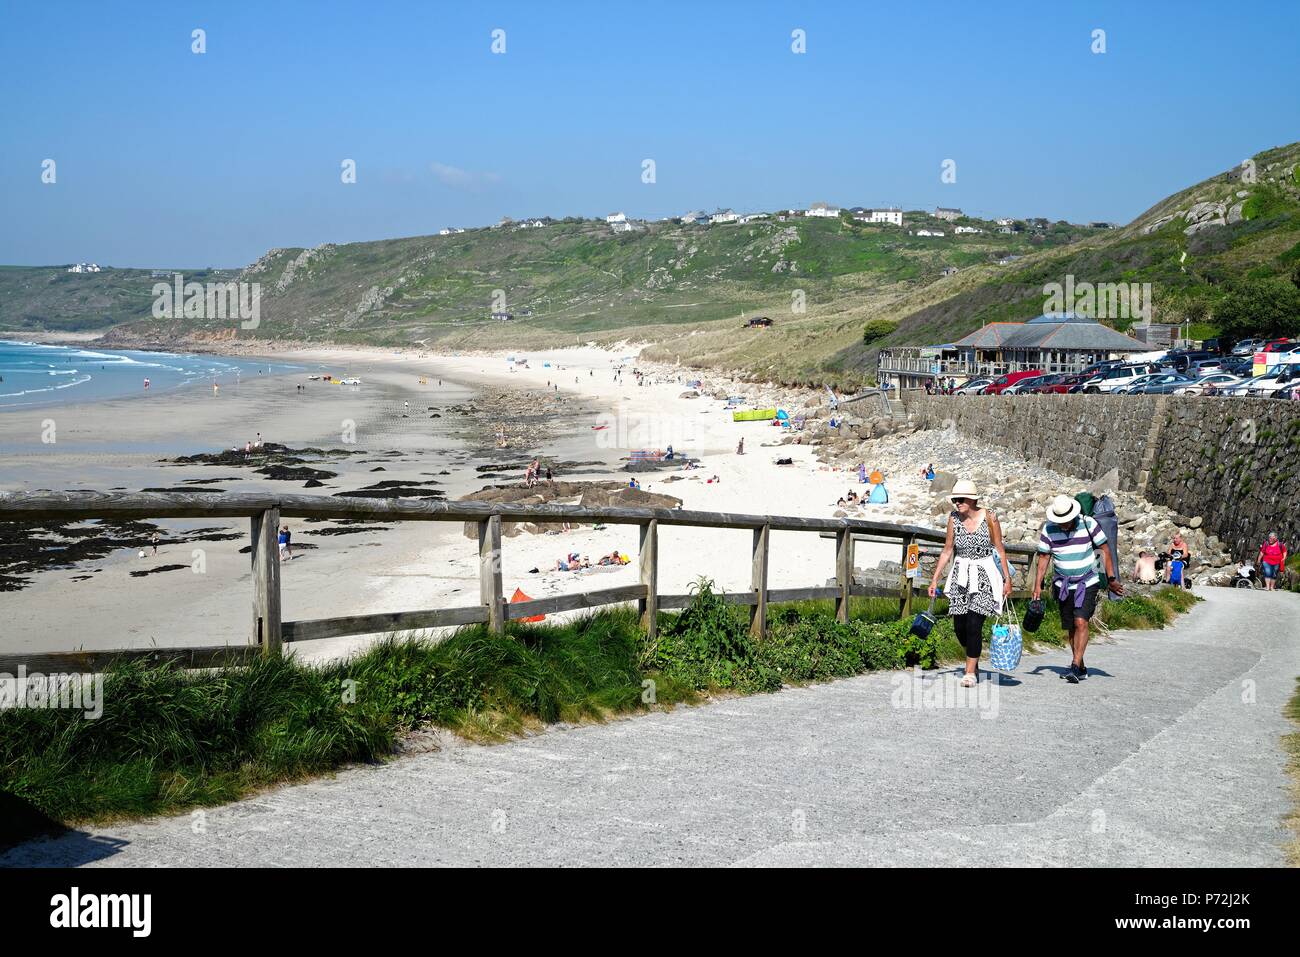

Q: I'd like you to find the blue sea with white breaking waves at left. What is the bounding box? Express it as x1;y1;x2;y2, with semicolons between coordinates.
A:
0;339;300;412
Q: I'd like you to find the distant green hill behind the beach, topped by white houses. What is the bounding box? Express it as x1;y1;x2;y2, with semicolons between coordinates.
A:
81;213;1084;358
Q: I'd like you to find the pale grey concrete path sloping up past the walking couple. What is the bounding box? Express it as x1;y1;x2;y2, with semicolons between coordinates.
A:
0;589;1300;867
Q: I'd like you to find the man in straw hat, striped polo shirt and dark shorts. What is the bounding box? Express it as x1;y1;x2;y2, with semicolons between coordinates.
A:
1034;495;1125;684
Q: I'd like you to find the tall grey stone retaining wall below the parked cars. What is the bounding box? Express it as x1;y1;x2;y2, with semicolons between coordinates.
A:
906;393;1300;558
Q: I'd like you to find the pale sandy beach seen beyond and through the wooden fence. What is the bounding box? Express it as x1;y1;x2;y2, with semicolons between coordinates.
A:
0;347;910;658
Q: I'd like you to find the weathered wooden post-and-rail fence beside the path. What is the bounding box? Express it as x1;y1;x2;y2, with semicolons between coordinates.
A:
0;492;1037;672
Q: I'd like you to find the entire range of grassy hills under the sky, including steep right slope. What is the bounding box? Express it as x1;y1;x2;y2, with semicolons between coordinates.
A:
12;143;1300;385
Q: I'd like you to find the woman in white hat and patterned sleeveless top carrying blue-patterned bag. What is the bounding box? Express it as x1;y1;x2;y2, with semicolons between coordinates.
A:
930;479;1011;688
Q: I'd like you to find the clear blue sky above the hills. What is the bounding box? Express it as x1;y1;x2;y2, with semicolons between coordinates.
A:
0;0;1300;268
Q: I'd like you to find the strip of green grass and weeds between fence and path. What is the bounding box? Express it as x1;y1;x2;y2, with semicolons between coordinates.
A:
0;583;1193;846
